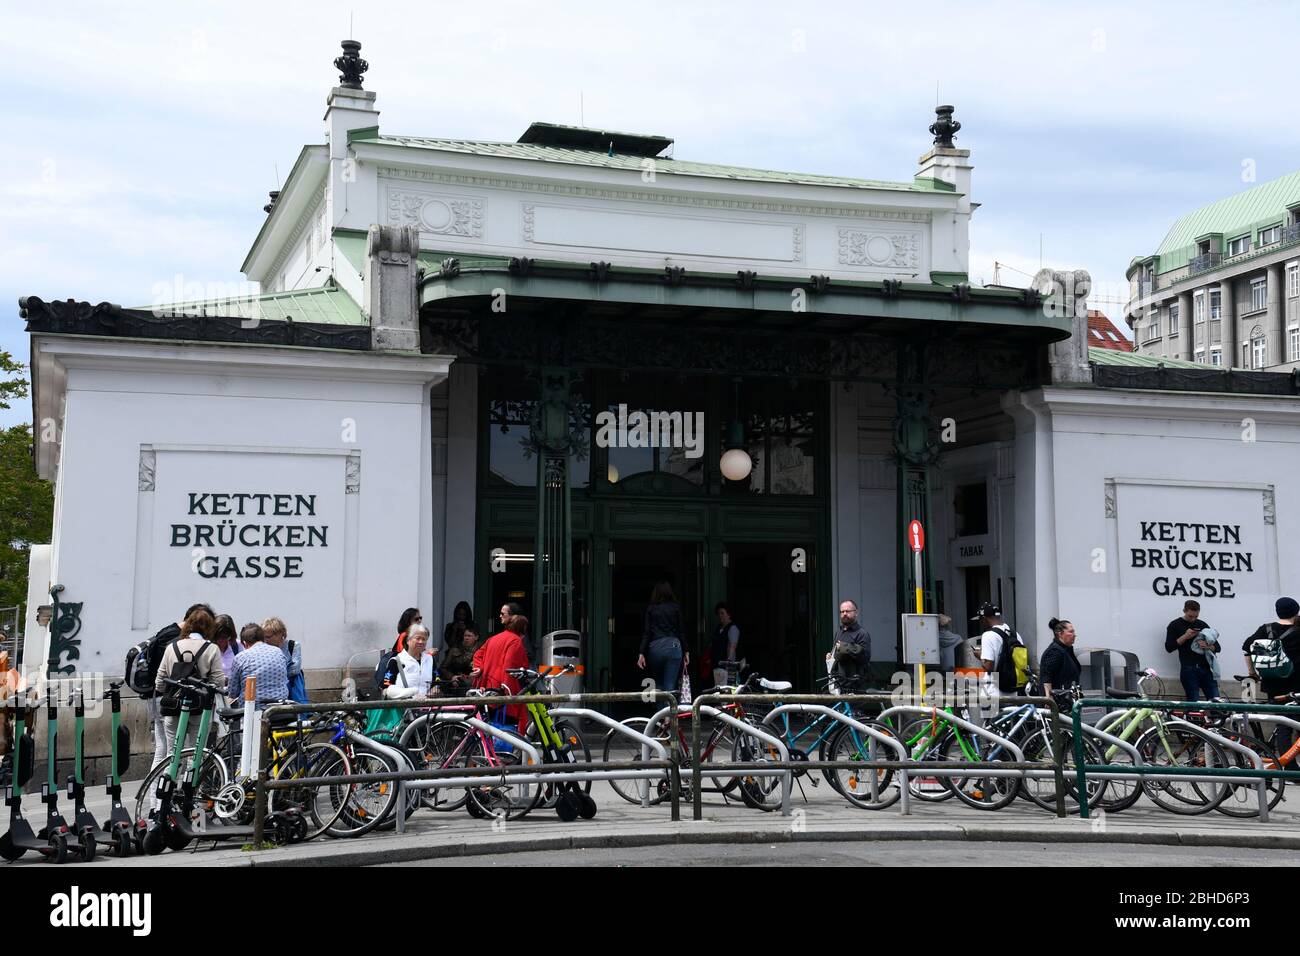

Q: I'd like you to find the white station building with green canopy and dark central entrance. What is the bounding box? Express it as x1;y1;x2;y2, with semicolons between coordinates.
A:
21;44;1300;712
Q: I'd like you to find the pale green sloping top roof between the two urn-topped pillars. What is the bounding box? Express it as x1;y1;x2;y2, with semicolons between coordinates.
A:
352;135;952;193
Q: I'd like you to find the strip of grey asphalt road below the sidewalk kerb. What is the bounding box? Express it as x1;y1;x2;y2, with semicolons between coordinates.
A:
385;840;1300;866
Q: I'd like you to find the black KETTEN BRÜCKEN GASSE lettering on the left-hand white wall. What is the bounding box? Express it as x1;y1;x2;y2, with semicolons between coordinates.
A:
169;492;330;579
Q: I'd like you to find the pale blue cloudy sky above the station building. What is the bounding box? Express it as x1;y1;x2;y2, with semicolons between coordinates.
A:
0;0;1300;425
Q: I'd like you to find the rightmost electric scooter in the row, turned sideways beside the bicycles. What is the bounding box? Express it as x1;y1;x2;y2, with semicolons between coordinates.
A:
143;678;308;856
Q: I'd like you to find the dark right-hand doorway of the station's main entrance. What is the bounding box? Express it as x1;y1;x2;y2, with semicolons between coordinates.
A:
709;542;824;692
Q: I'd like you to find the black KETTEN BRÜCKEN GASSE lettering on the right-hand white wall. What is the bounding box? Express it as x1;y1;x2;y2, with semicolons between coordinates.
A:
1127;519;1256;598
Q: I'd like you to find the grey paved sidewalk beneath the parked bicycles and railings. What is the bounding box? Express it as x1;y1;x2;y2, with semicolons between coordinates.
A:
5;778;1300;866
